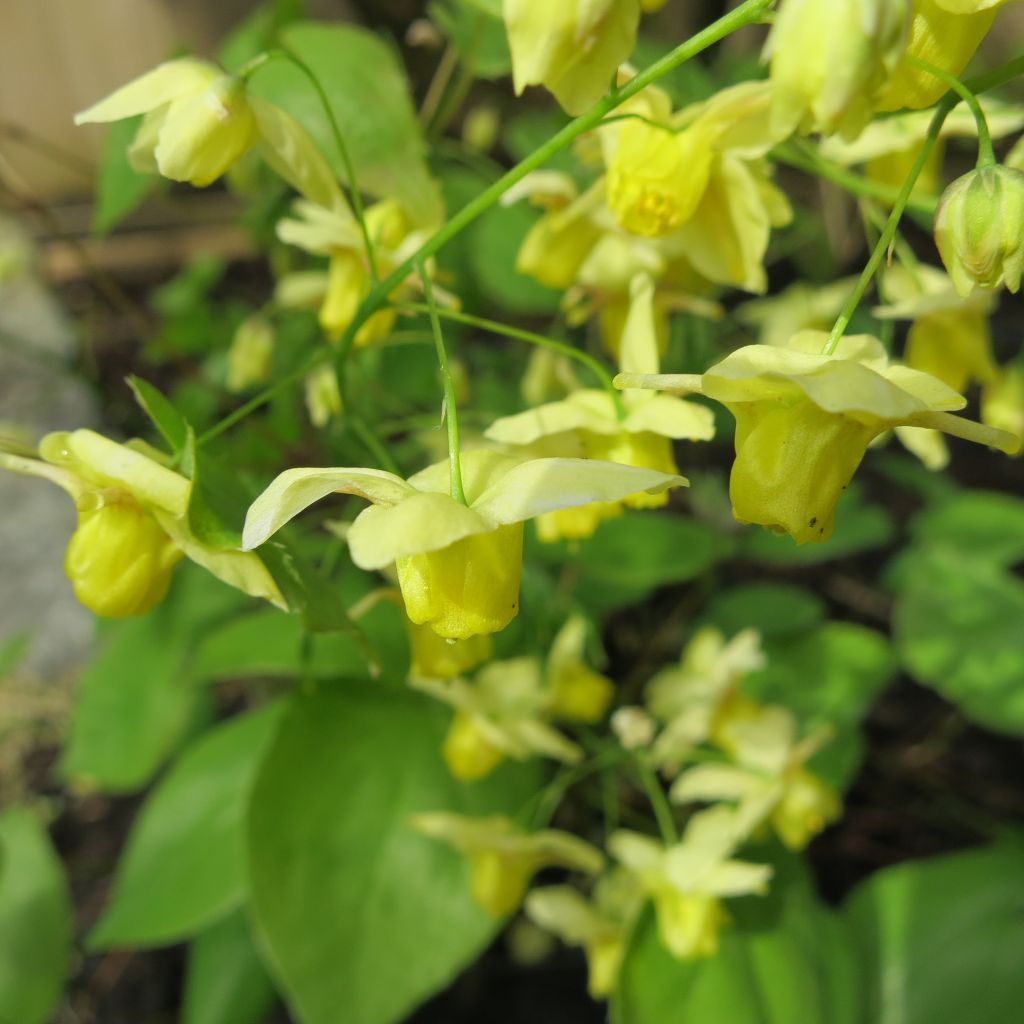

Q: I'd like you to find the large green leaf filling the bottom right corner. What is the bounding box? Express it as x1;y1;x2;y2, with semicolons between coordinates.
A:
844;842;1024;1024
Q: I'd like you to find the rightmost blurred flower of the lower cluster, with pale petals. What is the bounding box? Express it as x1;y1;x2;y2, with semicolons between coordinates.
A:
670;700;842;850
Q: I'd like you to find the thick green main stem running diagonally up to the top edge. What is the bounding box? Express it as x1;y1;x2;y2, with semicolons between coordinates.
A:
337;0;774;370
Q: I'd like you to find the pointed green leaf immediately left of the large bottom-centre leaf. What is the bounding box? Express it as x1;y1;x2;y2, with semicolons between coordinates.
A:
89;705;282;949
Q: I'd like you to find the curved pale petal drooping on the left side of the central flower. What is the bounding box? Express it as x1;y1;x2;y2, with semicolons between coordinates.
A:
242;468;414;551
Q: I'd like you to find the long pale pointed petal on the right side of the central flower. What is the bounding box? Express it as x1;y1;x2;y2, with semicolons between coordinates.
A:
473;459;688;523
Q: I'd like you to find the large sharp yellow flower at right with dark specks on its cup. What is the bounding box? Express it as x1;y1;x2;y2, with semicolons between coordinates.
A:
616;331;1020;544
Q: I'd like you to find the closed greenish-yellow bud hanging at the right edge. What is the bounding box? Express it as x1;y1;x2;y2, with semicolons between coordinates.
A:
935;165;1024;295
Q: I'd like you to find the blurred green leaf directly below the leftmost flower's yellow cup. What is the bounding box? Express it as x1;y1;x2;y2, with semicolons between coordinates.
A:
60;564;248;793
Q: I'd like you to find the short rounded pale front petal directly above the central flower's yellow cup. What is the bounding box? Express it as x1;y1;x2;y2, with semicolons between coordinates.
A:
348;488;496;569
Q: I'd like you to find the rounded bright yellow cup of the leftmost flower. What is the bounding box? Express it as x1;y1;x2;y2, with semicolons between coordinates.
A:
65;499;181;618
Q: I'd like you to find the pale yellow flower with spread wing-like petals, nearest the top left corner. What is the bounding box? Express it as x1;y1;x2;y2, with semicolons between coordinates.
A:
75;57;343;207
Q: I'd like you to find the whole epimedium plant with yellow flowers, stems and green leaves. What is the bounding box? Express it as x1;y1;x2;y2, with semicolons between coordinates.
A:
0;0;1024;1024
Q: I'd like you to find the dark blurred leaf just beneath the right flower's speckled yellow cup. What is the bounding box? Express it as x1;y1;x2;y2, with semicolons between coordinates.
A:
741;483;895;565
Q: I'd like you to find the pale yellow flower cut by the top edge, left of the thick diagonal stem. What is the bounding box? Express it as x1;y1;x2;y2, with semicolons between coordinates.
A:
503;0;640;114
